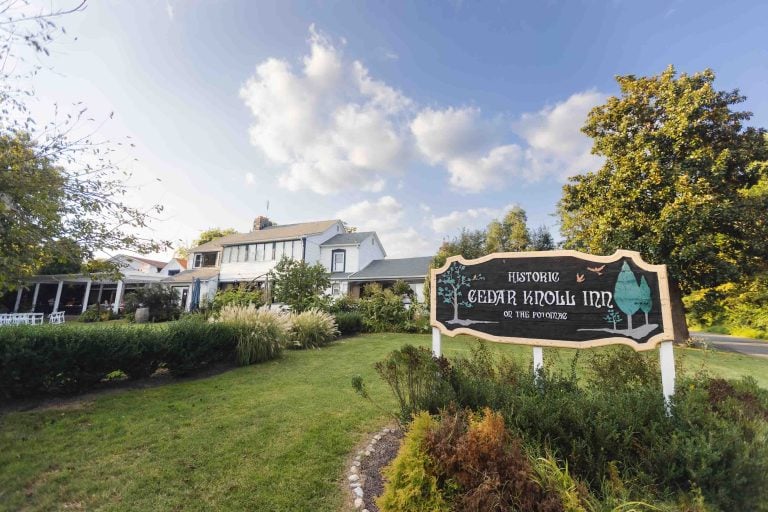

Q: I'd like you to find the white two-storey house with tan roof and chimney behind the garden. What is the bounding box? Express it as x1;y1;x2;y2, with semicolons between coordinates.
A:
164;216;429;309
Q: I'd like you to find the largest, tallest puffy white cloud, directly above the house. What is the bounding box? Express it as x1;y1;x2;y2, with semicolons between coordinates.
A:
240;27;411;194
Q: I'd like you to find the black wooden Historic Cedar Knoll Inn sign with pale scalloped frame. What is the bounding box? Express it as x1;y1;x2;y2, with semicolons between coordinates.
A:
430;251;674;350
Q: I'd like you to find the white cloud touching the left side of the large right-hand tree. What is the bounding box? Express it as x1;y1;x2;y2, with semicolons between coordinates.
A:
515;91;607;179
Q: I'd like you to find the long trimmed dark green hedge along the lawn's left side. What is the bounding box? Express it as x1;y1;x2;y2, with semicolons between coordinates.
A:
0;317;260;399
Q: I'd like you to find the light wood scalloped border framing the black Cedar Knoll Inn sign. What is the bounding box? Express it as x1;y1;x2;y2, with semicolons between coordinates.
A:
430;250;675;351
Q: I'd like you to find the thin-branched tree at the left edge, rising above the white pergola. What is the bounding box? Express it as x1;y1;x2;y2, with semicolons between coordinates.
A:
0;0;167;293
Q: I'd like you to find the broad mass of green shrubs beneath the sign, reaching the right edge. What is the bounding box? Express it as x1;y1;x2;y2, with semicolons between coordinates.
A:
366;345;768;511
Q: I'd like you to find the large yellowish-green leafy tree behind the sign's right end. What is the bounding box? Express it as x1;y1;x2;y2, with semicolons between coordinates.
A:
559;67;768;292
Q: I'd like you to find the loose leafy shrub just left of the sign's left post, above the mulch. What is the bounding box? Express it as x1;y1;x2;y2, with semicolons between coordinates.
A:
375;345;454;421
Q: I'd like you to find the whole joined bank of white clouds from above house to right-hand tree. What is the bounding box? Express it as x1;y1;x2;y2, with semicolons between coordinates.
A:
240;25;606;194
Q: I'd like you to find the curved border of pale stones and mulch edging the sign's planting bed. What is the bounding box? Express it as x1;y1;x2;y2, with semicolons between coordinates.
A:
346;426;402;512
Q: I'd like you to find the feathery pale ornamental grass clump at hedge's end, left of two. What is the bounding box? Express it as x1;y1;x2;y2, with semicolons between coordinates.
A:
219;304;291;366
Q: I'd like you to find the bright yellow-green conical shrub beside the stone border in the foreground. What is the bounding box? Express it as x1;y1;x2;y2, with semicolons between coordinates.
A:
376;412;451;512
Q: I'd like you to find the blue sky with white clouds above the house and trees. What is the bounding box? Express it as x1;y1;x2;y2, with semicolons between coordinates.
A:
24;0;768;256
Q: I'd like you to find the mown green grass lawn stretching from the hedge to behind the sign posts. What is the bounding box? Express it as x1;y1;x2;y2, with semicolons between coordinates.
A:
0;334;768;511
